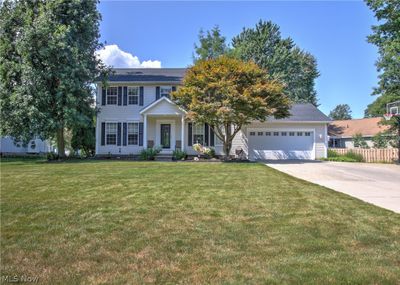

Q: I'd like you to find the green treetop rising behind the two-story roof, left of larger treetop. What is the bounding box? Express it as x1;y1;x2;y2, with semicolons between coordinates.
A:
193;26;229;62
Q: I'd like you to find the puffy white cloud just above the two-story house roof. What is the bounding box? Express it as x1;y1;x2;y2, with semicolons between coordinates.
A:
96;45;161;68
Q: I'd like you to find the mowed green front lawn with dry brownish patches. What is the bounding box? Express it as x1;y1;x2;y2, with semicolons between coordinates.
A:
1;159;400;284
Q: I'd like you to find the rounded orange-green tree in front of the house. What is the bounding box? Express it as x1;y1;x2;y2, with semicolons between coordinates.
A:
172;56;290;156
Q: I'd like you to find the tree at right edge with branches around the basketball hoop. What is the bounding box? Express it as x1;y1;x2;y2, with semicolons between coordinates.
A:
365;0;400;117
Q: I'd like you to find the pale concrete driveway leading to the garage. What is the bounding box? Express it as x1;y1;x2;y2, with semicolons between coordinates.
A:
266;160;400;213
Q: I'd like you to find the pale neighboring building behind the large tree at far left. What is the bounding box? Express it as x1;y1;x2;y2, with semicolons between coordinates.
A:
0;136;52;155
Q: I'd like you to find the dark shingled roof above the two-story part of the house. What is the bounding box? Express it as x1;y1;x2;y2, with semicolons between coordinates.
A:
100;68;186;84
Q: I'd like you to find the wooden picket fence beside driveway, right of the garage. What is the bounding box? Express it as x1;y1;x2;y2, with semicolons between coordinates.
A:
330;148;398;162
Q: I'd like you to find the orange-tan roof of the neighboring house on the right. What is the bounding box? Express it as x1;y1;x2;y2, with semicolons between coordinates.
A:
328;118;389;138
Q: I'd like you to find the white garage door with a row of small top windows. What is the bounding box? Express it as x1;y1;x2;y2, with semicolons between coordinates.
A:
247;129;315;160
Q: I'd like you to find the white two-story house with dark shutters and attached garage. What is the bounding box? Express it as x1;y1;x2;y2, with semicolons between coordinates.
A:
96;68;330;160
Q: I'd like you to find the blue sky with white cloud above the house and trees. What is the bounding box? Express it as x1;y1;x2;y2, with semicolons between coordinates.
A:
99;1;378;118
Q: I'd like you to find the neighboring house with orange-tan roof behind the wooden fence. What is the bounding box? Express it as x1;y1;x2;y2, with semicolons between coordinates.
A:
328;118;389;148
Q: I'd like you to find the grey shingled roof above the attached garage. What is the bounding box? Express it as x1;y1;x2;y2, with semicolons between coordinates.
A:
268;103;331;123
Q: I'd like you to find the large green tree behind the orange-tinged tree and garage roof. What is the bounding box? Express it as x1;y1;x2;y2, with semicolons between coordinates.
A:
232;21;319;105
